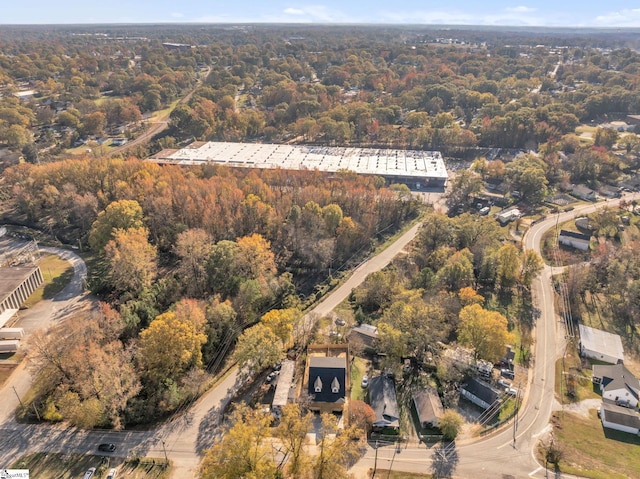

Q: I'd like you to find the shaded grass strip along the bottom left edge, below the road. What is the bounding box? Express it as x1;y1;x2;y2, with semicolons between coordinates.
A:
11;453;171;479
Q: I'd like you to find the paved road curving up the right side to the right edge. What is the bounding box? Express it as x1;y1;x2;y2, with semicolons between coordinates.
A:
352;194;640;479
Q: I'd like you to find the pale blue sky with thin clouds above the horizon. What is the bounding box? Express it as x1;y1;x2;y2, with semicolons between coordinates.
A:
0;0;640;28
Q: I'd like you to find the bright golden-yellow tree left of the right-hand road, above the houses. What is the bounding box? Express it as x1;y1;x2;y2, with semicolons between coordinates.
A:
458;304;512;362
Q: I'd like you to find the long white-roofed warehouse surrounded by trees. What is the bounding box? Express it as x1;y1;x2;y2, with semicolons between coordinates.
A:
150;142;448;188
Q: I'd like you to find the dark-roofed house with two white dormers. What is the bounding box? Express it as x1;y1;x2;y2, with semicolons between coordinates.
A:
305;345;349;412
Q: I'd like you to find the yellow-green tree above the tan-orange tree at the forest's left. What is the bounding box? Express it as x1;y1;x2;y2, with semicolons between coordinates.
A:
89;200;144;252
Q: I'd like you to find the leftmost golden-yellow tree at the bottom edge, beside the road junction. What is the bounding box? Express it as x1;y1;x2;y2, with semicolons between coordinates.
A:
200;404;276;479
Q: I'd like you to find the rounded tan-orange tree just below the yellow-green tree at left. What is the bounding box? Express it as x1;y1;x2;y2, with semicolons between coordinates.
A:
104;228;157;296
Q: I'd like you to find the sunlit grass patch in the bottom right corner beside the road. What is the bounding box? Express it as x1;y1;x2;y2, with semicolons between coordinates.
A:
543;409;640;479
